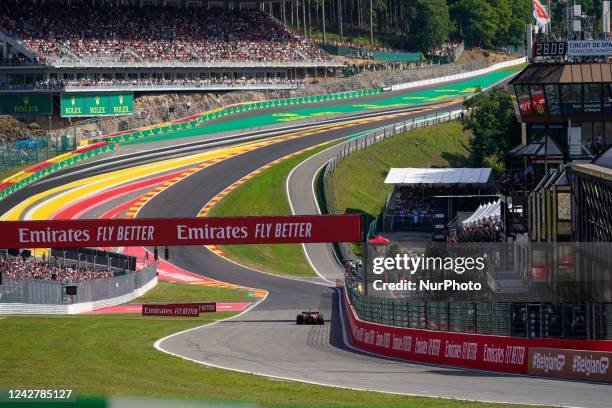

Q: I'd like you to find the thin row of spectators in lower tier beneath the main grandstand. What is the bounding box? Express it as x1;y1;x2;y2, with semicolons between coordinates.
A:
34;77;304;90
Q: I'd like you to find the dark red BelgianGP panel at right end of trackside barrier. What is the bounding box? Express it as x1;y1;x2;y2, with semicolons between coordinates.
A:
528;347;612;382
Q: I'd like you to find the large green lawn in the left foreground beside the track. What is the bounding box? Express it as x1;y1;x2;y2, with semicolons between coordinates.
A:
0;284;532;408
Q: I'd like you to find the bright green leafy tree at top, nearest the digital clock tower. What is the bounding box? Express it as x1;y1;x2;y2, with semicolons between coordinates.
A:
451;0;497;47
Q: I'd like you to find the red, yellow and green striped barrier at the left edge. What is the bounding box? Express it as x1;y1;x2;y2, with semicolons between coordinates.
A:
0;142;116;200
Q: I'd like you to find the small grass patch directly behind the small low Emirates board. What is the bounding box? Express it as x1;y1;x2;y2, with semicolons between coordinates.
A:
130;281;258;304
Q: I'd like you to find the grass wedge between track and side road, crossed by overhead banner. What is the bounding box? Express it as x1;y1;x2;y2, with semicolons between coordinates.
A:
209;144;338;276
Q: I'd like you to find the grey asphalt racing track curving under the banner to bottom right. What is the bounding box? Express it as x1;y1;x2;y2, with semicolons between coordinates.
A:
139;116;612;407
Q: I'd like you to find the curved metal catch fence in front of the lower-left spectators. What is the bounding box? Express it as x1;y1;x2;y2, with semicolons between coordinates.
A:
0;263;157;305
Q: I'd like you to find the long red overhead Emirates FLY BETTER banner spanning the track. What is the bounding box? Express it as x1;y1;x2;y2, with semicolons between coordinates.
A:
0;214;362;248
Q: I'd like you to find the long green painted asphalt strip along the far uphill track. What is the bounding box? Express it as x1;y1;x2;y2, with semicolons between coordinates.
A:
122;71;514;144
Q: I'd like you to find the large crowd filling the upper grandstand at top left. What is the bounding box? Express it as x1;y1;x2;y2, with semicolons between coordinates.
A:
0;2;331;62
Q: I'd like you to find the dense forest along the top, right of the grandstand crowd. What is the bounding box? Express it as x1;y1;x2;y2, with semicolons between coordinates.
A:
271;0;601;53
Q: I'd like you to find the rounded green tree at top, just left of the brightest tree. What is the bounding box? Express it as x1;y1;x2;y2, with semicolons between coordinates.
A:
411;0;451;53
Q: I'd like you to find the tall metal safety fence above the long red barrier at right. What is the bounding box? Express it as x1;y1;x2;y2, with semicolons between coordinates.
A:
345;277;612;340
